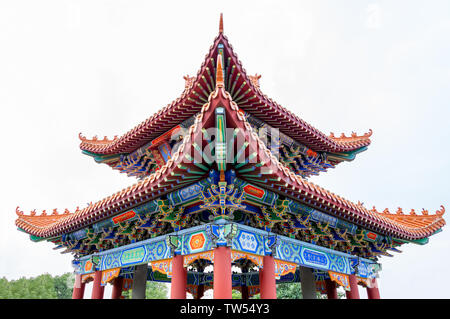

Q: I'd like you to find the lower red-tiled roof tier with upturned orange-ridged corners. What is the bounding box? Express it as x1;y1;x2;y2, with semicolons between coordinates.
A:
16;88;445;244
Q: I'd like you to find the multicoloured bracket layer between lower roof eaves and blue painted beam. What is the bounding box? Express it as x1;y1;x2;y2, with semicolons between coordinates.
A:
16;171;442;258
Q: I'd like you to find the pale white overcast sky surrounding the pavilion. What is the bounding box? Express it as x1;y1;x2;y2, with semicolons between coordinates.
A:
0;0;450;298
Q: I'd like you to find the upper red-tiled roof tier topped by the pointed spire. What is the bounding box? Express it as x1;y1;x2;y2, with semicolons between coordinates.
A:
80;15;372;177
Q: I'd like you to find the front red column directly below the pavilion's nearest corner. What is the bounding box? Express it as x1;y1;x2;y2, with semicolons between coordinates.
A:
213;246;232;299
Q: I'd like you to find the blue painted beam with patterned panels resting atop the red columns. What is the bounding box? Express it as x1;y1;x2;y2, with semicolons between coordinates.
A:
74;220;381;278
